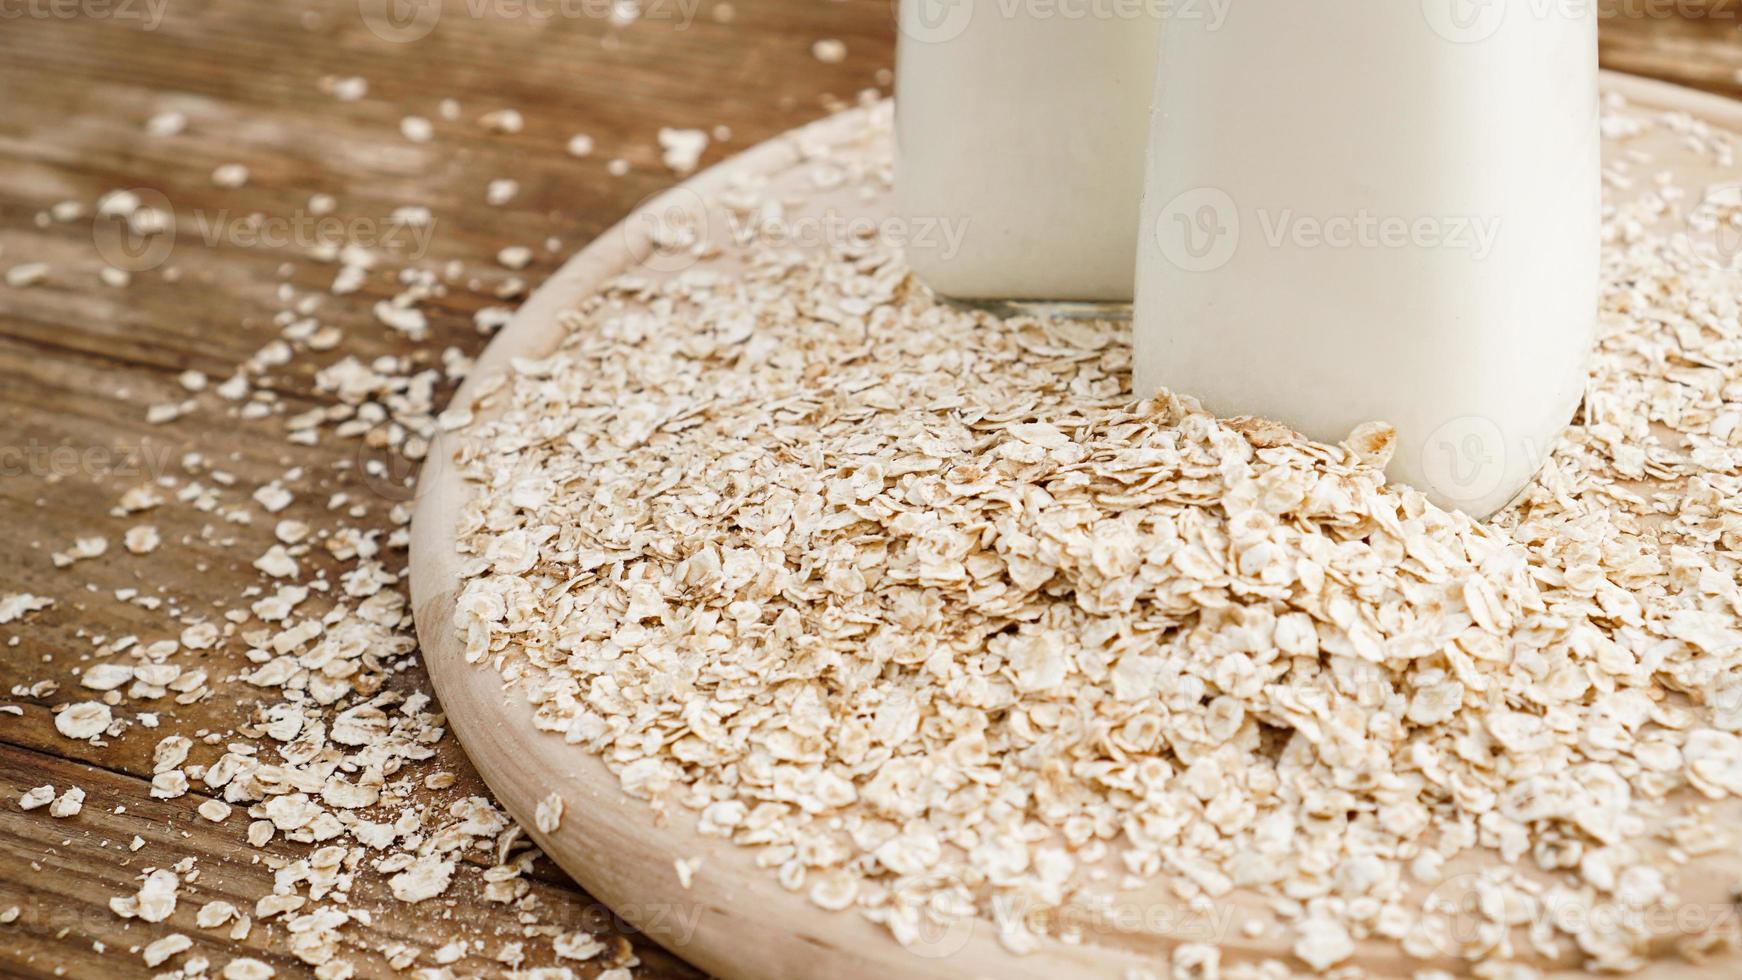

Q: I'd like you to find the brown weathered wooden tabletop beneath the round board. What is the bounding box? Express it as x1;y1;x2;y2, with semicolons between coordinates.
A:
0;0;1742;977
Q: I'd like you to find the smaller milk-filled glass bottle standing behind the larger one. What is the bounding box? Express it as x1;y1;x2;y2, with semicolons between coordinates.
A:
895;0;1160;303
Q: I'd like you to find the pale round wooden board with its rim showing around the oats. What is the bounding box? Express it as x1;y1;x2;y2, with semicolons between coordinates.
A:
411;73;1742;980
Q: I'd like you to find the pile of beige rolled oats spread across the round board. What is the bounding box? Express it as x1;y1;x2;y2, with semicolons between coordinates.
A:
446;99;1742;977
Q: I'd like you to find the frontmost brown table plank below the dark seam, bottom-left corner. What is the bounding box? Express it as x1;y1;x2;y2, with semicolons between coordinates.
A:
0;745;707;977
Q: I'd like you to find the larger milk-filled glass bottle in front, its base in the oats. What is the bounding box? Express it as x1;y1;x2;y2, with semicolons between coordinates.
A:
1134;0;1601;517
